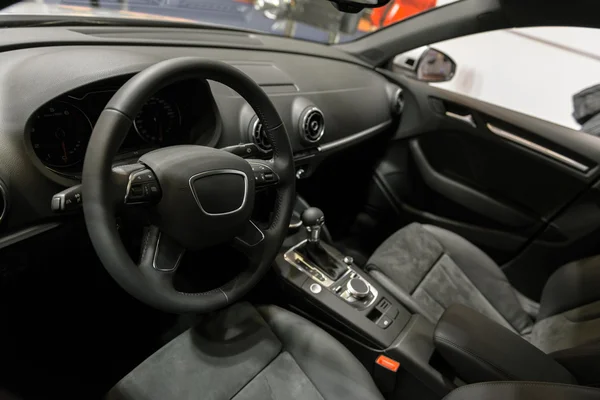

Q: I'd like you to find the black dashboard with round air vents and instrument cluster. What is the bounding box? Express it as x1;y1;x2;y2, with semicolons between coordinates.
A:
0;27;402;239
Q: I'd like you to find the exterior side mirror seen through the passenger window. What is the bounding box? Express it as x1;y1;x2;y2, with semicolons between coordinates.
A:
392;46;456;82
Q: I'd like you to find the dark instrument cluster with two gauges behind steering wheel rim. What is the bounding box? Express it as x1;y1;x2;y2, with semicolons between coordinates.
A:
27;78;218;179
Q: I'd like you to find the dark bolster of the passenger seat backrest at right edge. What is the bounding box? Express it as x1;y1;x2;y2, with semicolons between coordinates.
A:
538;256;600;320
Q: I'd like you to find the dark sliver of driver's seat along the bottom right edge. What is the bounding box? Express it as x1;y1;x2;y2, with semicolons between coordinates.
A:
444;382;600;400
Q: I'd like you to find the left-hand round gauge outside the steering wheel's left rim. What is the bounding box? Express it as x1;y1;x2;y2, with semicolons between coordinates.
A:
31;101;92;168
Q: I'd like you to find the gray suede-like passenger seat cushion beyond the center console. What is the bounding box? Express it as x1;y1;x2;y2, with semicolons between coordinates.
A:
366;223;533;335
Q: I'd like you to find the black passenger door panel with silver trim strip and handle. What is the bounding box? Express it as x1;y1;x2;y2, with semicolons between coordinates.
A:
370;71;600;298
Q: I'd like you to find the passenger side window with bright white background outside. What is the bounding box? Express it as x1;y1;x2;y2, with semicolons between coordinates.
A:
394;27;600;135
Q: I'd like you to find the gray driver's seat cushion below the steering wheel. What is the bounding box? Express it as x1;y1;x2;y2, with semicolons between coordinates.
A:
107;303;383;400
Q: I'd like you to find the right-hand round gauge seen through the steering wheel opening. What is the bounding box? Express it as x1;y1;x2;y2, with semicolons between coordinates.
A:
133;96;180;145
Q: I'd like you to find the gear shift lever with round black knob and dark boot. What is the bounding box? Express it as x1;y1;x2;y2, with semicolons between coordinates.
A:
301;207;347;281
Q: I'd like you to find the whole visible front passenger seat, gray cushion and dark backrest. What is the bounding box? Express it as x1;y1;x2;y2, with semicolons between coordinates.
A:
365;223;600;353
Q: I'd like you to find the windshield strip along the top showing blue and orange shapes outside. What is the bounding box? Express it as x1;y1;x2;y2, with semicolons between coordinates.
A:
0;0;455;43
